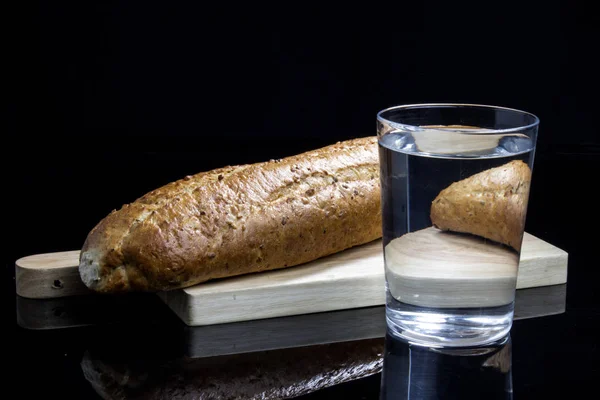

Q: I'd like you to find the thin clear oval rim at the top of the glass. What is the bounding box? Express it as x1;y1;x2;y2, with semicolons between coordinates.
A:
377;103;540;135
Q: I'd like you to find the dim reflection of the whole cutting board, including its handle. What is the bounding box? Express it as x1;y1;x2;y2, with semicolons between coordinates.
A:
16;284;567;332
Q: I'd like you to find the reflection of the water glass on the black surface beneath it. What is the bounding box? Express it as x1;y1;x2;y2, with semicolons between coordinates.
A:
380;333;512;400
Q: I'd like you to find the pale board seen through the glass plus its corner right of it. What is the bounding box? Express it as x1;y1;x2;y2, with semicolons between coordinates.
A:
385;228;567;308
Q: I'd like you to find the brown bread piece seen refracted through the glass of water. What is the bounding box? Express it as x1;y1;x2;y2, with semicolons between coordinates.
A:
431;161;531;251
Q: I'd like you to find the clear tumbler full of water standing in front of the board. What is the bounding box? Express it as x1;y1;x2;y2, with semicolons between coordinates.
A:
377;104;539;347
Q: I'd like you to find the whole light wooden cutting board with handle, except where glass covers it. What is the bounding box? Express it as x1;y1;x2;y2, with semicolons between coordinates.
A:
16;230;567;325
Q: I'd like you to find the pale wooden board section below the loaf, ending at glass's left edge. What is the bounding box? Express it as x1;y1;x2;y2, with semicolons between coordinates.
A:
159;241;385;326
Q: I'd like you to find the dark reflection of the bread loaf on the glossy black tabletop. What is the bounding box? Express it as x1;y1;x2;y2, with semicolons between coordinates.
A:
81;338;384;399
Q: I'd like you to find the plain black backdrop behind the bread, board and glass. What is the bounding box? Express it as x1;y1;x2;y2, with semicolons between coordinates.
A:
2;1;600;395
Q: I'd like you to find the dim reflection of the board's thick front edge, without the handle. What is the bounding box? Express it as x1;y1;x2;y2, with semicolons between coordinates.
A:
182;284;566;358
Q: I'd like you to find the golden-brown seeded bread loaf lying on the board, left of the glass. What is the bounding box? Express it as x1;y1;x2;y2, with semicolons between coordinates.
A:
79;137;381;293
